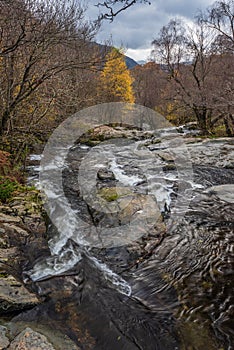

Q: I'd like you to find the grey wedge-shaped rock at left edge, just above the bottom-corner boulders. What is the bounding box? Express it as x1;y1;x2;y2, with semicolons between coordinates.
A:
0;275;40;312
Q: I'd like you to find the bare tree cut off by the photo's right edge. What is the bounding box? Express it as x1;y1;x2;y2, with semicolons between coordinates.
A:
200;0;234;136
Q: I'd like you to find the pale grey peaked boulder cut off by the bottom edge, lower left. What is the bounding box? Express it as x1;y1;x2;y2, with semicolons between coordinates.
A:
9;327;55;350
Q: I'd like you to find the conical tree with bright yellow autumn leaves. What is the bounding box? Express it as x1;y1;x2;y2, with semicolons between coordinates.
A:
99;48;135;103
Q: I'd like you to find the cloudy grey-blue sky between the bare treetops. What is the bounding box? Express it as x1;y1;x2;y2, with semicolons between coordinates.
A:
88;0;214;61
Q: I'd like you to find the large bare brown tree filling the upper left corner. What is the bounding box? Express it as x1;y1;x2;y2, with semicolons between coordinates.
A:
0;0;100;134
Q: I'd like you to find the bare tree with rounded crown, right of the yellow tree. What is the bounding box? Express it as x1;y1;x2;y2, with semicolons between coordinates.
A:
153;19;218;133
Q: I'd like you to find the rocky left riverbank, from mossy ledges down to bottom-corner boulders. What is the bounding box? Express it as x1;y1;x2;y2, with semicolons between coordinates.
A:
0;187;83;350
